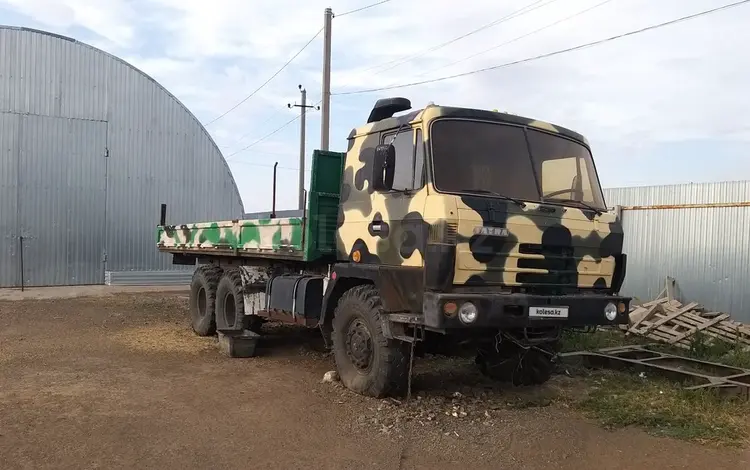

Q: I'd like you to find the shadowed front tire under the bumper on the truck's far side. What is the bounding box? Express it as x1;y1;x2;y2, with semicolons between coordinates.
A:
475;341;560;386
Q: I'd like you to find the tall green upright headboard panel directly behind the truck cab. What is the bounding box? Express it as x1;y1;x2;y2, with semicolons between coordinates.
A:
304;150;346;261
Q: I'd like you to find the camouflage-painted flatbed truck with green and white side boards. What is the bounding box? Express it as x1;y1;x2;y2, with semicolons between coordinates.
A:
158;98;630;396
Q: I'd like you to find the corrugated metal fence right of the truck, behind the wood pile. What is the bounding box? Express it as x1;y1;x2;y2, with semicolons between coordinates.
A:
604;181;750;322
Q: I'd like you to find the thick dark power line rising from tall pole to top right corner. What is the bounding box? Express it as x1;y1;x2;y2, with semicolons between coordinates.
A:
331;0;750;96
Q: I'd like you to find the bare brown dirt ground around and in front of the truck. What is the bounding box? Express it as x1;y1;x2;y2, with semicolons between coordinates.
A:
0;292;750;470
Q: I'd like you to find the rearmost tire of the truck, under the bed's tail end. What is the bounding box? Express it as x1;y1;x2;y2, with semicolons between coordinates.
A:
189;265;222;336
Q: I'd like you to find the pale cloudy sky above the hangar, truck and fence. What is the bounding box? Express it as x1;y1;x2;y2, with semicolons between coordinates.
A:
0;0;750;211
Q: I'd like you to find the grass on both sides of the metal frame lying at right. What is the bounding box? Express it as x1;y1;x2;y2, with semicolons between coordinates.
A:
562;329;750;445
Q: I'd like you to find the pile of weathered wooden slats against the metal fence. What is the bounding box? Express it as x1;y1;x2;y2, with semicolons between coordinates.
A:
626;278;750;349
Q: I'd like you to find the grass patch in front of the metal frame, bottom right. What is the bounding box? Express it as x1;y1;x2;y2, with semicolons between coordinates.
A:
572;371;750;445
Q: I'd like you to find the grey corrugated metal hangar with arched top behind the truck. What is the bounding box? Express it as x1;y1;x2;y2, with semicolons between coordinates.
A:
0;26;244;287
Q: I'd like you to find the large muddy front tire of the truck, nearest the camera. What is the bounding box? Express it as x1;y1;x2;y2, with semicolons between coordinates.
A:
331;285;410;398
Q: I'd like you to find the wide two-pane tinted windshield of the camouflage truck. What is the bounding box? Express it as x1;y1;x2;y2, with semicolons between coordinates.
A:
430;119;605;209
